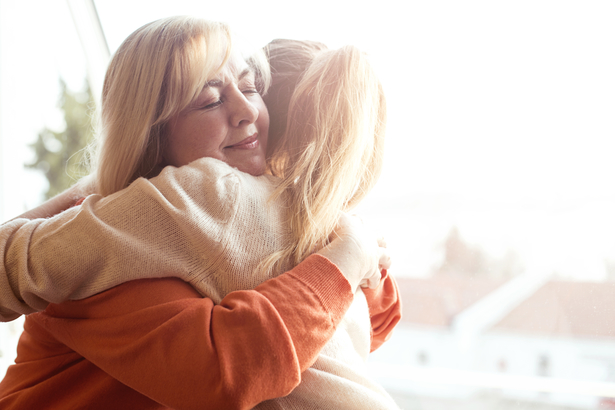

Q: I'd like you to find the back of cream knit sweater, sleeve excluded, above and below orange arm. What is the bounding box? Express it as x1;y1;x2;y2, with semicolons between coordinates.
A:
178;160;397;410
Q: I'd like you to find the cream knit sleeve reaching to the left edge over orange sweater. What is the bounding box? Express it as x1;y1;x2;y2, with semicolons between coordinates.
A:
0;158;239;321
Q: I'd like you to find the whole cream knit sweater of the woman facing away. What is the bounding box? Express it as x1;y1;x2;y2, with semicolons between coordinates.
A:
0;158;397;410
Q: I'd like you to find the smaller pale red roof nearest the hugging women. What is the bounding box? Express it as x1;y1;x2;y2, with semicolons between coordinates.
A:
395;275;505;327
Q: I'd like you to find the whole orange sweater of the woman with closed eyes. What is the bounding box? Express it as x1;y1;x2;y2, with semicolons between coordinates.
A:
0;255;400;409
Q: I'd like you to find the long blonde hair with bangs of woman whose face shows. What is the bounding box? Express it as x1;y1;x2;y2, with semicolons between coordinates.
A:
92;17;269;195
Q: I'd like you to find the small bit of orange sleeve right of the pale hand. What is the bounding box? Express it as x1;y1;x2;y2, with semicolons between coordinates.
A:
363;269;401;352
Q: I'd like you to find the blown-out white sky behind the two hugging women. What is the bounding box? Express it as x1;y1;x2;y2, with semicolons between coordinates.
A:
0;0;615;279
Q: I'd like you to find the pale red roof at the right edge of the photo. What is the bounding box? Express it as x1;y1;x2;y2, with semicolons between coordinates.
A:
492;281;615;338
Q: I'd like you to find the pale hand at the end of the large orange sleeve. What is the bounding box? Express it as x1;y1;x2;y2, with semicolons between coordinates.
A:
318;213;391;291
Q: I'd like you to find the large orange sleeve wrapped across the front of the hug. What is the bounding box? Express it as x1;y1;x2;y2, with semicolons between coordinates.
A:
41;255;352;409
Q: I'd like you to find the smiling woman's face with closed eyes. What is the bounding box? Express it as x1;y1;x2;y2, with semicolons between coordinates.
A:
162;58;269;175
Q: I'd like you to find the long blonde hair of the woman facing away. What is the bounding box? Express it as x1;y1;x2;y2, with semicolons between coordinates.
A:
261;45;386;271
